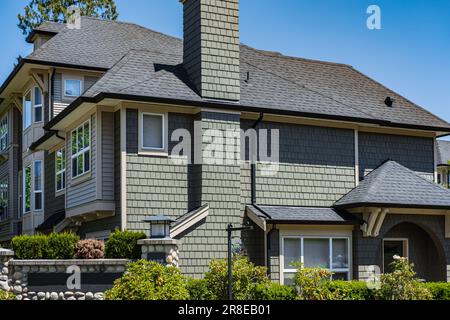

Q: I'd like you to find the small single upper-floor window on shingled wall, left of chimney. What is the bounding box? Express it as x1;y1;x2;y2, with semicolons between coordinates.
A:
139;112;167;151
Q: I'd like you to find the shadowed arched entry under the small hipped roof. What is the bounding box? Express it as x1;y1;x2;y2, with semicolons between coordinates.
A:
382;222;446;282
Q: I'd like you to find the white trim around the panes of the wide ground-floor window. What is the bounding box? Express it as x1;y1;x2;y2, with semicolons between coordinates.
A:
280;235;352;284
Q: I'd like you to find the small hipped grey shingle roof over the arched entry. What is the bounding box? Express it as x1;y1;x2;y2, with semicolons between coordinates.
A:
334;161;450;209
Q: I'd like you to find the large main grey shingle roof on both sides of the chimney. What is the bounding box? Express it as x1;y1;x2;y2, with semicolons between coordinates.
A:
15;17;450;131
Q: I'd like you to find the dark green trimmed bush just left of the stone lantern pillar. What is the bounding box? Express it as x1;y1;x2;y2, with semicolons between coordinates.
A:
105;230;146;260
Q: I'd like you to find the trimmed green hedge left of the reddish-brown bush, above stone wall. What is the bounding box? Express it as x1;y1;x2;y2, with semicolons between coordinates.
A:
11;233;79;260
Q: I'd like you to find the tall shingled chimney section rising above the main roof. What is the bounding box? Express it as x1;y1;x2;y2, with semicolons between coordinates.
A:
180;0;240;101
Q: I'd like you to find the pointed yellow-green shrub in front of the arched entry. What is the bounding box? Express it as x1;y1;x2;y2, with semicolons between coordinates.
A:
376;256;432;300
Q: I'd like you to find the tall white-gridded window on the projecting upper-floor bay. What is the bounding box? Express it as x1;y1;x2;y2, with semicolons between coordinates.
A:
71;121;91;178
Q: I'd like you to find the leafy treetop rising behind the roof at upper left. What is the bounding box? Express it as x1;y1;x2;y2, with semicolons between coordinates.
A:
18;0;119;35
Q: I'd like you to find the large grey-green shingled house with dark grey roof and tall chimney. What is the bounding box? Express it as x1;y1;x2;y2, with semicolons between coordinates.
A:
0;0;450;283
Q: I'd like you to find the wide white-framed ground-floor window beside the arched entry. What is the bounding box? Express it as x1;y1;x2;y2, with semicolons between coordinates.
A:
281;236;351;285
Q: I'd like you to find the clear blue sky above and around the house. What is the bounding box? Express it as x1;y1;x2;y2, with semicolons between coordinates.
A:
0;0;450;127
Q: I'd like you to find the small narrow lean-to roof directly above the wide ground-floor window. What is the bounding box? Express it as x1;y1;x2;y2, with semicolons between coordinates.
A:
249;205;359;224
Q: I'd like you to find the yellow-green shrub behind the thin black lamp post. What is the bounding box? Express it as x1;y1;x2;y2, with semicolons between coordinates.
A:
205;255;269;300
